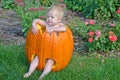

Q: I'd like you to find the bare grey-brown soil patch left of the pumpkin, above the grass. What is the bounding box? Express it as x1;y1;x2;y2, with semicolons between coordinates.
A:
0;8;25;45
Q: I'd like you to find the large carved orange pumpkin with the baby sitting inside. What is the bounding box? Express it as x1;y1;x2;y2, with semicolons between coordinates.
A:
26;23;74;71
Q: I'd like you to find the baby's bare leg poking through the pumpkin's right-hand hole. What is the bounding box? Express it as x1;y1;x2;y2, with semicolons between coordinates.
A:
39;59;54;80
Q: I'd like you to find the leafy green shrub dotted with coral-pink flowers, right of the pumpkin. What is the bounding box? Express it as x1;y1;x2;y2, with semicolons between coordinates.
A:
85;23;120;51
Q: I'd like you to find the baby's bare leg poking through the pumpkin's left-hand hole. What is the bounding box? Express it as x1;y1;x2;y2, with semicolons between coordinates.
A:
24;56;39;78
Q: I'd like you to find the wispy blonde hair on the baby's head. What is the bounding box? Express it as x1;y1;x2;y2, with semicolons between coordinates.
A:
47;4;66;19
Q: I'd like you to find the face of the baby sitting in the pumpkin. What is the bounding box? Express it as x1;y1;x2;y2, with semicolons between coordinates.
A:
46;11;61;26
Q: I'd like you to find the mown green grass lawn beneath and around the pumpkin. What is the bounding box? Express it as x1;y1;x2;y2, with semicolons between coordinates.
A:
0;45;120;80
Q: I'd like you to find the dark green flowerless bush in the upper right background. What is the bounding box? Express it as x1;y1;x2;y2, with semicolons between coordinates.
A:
65;0;120;20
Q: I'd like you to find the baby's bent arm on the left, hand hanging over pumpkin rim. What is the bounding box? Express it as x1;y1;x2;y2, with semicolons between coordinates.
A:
32;19;45;33
